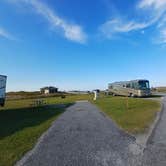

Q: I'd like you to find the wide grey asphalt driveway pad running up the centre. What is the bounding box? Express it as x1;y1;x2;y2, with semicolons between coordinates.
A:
17;102;142;166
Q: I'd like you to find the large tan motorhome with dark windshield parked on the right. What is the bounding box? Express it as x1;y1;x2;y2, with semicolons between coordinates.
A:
108;80;151;97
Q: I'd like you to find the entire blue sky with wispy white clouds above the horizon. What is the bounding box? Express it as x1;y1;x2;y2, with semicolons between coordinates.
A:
0;0;166;91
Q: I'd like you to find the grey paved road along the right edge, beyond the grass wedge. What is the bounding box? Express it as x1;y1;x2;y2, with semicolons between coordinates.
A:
142;97;166;166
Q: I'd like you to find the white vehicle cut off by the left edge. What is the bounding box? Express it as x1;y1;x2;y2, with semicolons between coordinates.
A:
0;75;7;107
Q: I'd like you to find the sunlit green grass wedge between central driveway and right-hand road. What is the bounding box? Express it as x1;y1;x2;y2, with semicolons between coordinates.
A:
94;97;161;134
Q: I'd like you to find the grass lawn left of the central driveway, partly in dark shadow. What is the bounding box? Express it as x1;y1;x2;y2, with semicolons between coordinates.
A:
0;95;90;166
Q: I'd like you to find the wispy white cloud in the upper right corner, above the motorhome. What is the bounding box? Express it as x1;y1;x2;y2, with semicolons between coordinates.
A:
100;0;166;43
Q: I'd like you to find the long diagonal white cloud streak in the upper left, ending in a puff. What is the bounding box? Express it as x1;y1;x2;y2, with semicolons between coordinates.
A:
10;0;87;43
